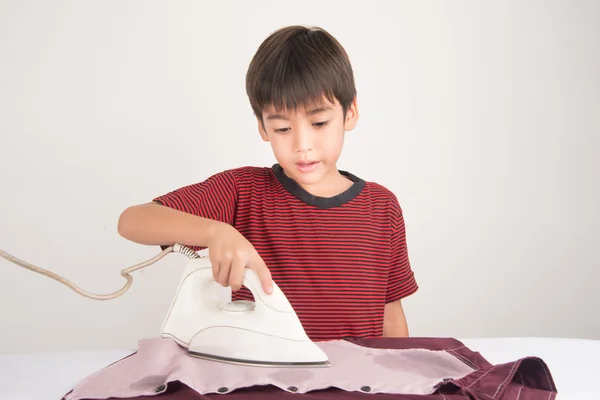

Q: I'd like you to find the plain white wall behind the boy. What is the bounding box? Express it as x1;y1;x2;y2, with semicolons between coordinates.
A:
0;0;600;352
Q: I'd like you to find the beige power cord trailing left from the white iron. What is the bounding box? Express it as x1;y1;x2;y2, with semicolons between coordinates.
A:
0;243;200;300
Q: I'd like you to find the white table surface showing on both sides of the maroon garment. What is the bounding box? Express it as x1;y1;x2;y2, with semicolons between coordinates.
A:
0;338;600;400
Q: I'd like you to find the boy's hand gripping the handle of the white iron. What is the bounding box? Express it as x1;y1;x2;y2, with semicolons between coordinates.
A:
207;224;272;294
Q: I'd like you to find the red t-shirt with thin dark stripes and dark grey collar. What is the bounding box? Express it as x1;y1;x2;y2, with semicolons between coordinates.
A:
154;164;417;341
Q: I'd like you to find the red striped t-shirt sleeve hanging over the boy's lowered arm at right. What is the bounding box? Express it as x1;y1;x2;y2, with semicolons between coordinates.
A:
386;197;418;303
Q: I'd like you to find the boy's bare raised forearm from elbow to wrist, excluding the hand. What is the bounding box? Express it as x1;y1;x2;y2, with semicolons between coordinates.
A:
117;203;222;246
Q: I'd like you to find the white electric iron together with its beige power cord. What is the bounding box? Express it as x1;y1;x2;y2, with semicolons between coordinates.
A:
0;244;330;368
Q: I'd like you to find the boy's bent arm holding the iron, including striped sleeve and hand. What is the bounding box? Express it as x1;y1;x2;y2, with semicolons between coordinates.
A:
118;172;272;293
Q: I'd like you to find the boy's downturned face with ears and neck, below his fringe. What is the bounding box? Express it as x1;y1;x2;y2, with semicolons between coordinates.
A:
258;97;358;196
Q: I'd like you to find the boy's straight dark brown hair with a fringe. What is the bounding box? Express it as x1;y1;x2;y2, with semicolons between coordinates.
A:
246;25;356;121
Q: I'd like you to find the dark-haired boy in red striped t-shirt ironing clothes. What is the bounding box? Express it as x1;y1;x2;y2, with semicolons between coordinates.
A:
118;26;417;341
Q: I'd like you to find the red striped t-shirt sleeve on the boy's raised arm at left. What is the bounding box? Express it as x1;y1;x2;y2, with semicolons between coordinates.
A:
153;171;237;250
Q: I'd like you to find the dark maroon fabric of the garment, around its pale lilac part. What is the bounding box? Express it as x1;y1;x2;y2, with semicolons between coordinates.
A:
62;338;557;400
